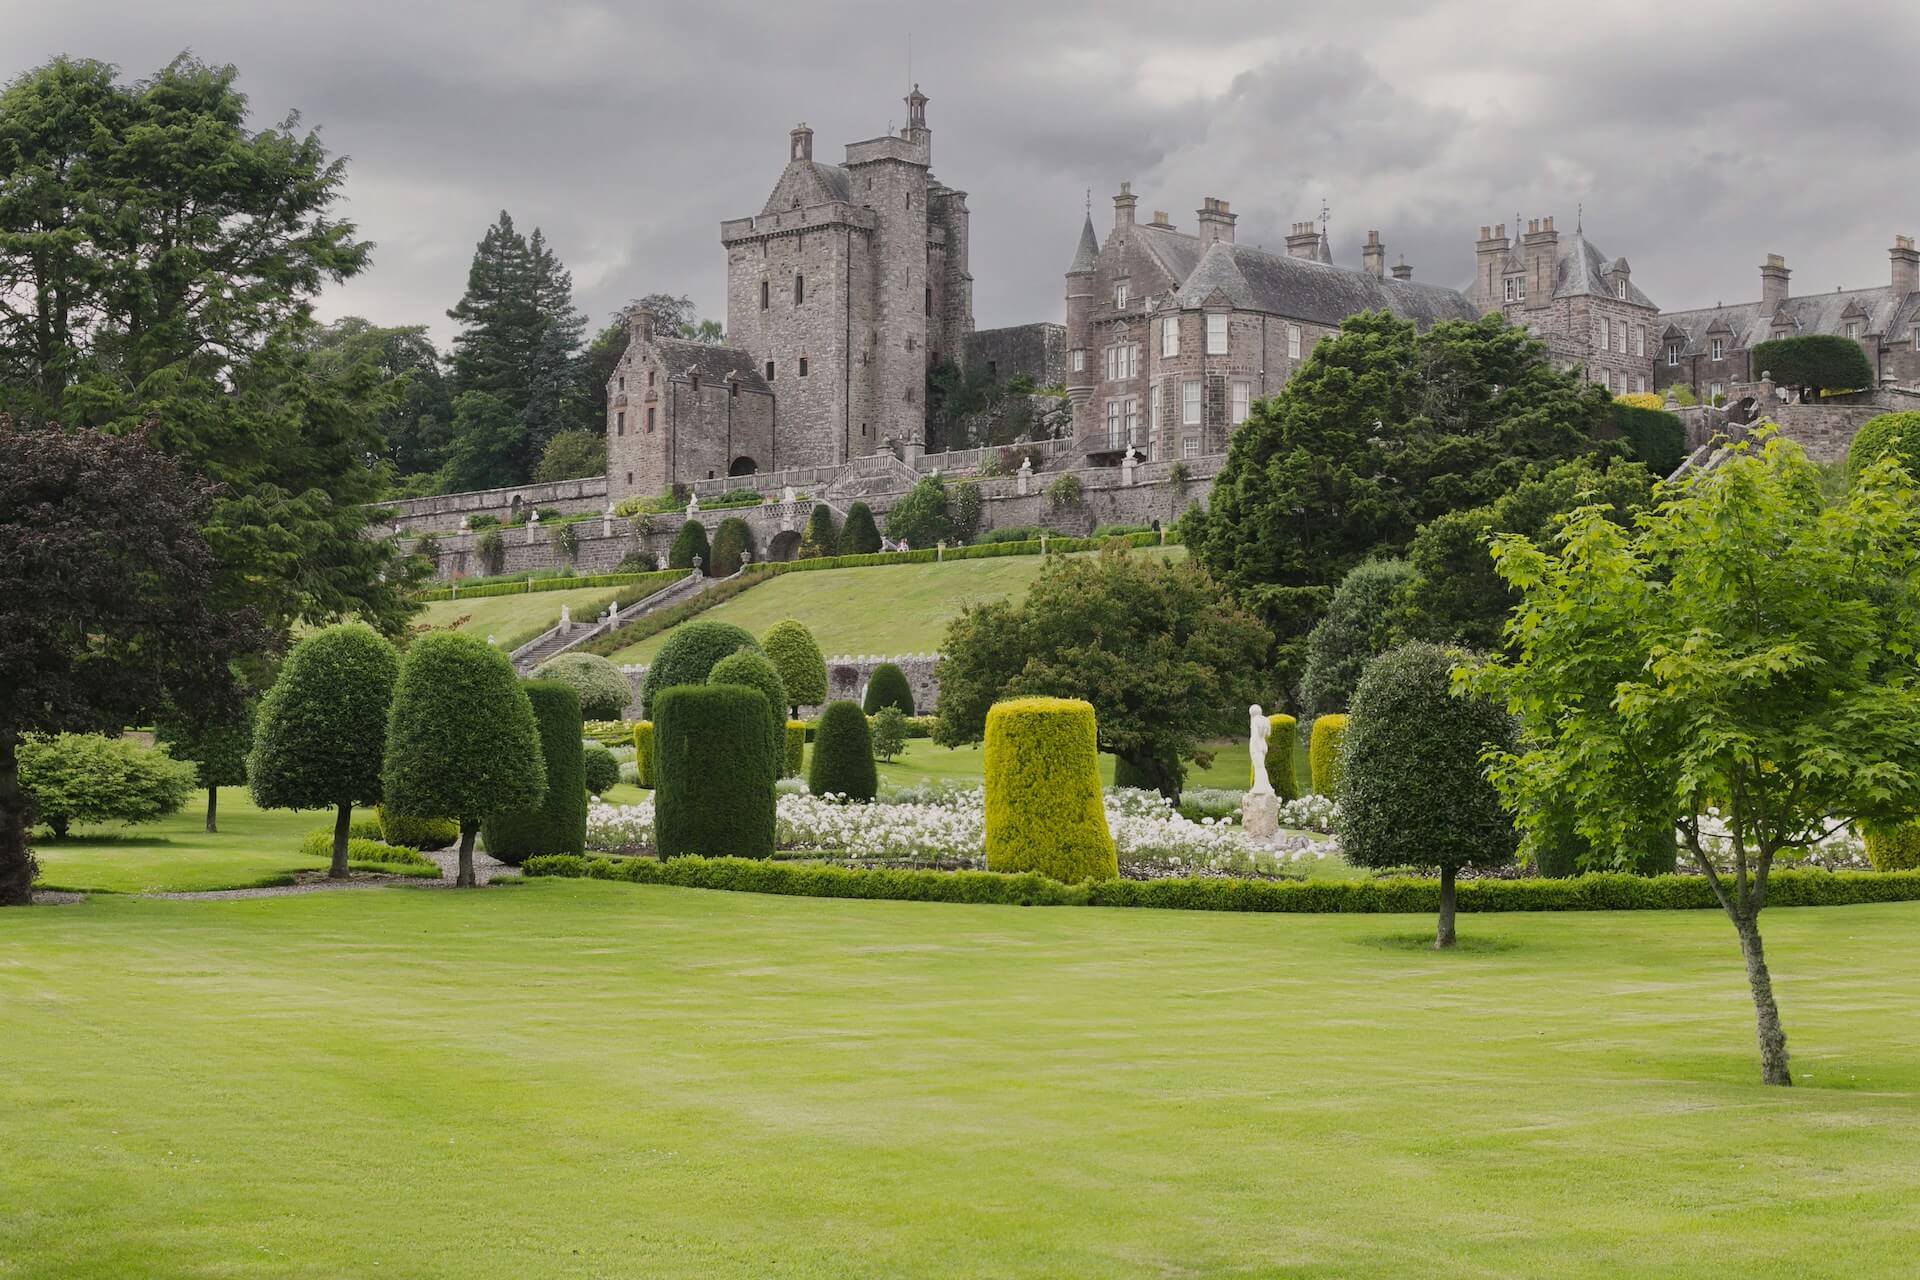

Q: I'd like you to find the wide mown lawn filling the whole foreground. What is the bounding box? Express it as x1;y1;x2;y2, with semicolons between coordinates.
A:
0;881;1920;1280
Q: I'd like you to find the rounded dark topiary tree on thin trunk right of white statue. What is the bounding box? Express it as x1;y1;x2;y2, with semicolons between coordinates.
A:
1340;643;1519;948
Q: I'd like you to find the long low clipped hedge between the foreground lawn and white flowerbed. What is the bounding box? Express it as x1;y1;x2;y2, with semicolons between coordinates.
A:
524;854;1920;915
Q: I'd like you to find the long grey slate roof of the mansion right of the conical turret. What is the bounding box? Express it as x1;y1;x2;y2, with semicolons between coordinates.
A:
1173;242;1480;326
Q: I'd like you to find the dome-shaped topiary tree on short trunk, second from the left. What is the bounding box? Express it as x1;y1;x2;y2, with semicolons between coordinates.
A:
384;631;549;885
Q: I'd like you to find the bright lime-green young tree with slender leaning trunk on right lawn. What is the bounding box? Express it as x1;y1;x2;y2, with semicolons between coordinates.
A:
1471;438;1920;1084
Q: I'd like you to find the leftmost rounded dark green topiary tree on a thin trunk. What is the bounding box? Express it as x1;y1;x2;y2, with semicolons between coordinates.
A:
248;622;399;879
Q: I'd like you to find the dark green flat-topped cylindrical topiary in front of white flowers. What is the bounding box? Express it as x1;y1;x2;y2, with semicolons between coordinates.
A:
653;685;778;858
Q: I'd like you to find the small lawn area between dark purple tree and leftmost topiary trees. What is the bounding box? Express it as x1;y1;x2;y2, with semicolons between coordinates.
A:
33;787;372;892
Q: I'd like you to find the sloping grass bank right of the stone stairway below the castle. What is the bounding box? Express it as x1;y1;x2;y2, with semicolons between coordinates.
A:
602;547;1187;662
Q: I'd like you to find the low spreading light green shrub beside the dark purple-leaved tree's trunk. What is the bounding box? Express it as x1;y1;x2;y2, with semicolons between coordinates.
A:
17;733;198;839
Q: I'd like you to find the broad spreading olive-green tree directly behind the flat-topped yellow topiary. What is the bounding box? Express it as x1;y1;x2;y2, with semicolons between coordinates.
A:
933;547;1271;796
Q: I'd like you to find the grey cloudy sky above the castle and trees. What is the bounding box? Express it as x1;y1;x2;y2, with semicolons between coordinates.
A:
15;0;1920;340
